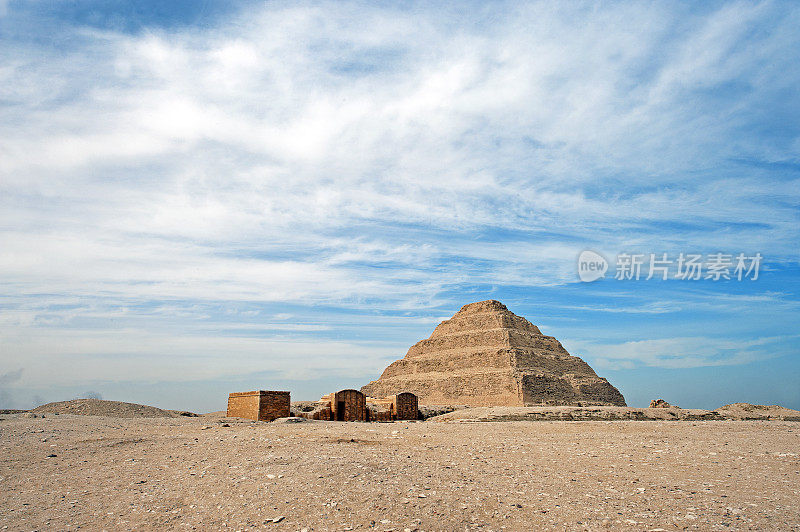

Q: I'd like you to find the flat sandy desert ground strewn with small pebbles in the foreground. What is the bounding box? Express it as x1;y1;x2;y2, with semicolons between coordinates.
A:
0;414;800;531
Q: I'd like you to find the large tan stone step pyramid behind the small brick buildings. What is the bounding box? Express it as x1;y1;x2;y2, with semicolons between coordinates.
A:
361;300;625;406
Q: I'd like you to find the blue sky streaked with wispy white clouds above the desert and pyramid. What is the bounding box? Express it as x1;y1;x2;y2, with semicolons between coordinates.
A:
0;0;800;412
